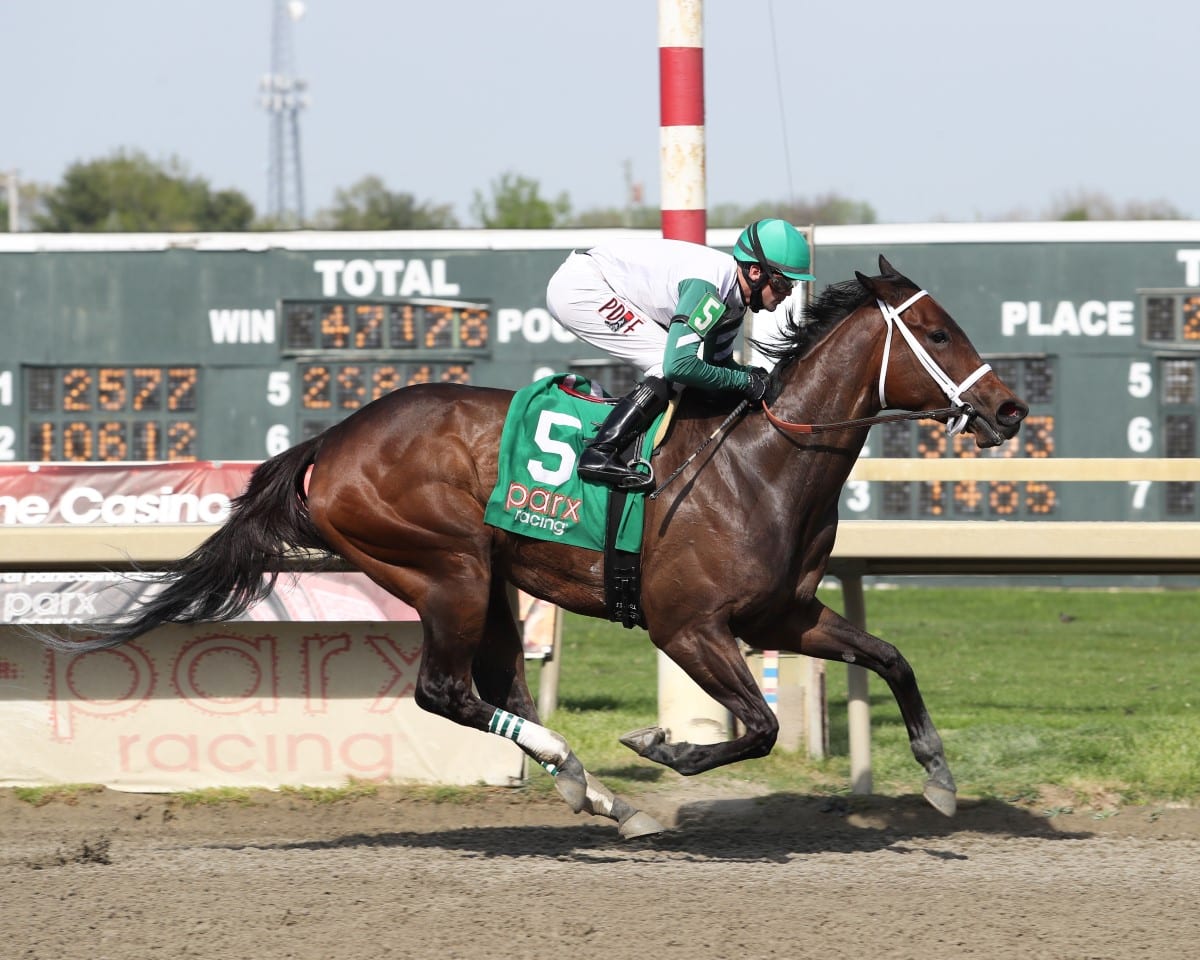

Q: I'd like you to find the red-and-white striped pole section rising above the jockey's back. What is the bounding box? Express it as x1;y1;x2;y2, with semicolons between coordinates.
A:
659;0;708;244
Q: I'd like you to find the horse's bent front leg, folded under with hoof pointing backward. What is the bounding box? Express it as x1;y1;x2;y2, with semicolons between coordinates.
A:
620;620;779;776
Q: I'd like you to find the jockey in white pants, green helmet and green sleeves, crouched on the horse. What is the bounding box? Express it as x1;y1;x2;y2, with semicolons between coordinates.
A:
546;220;814;491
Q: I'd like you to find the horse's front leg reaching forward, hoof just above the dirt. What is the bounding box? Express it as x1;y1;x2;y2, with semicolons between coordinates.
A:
787;600;958;816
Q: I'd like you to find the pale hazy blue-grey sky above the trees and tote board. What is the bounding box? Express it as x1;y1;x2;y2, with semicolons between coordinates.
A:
0;0;1200;226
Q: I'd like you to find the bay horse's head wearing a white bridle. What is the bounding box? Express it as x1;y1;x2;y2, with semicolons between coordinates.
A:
854;256;1030;448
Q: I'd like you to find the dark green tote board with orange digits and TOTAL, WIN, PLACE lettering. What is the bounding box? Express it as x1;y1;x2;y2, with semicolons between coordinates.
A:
0;223;1200;520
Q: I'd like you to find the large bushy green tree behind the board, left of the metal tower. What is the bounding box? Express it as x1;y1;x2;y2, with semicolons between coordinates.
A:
34;150;254;233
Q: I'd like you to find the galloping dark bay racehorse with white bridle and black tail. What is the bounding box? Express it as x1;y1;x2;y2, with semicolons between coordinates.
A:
42;257;1028;836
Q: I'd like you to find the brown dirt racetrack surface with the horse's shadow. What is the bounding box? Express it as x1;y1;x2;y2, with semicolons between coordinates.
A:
0;780;1200;960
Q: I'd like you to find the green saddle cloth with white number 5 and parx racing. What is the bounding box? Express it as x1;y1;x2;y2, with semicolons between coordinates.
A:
484;373;658;553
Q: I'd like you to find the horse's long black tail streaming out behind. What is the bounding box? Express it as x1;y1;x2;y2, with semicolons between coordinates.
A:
39;437;329;653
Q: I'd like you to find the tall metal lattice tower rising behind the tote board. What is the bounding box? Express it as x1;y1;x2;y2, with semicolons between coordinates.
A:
259;0;308;227
